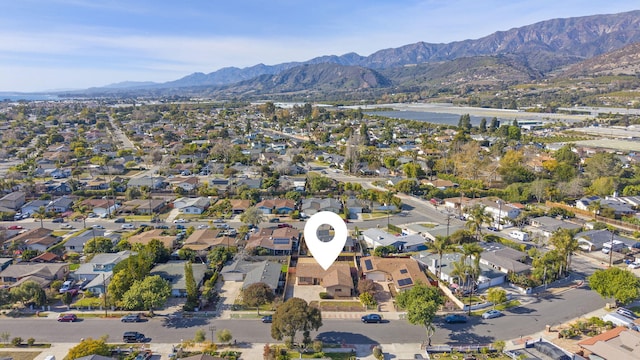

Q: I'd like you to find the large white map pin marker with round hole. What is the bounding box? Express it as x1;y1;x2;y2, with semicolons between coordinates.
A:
304;211;347;270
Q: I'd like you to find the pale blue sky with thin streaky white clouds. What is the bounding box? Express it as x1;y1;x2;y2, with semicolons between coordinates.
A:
0;0;640;91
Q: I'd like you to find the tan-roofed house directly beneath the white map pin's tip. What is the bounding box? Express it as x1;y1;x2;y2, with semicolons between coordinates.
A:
296;258;354;298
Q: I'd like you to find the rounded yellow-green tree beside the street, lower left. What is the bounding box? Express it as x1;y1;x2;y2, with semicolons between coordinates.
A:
122;275;171;312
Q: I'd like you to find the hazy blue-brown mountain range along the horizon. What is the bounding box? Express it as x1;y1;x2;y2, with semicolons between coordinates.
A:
74;10;640;99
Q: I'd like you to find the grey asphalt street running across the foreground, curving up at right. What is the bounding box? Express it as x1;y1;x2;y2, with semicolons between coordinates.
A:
0;286;605;345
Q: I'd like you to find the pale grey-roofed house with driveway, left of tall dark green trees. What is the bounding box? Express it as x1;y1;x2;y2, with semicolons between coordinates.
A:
71;250;132;294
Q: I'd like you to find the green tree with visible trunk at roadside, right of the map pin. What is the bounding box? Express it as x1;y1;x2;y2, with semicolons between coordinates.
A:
396;283;444;346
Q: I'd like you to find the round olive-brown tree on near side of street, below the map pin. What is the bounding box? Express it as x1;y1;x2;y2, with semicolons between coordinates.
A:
271;297;322;344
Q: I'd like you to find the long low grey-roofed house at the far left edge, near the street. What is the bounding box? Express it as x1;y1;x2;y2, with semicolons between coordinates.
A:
0;262;69;288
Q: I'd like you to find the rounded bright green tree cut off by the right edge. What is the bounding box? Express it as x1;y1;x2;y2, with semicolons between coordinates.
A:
588;267;640;304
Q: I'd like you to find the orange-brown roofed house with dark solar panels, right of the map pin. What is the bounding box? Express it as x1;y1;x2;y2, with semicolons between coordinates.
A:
359;256;430;292
